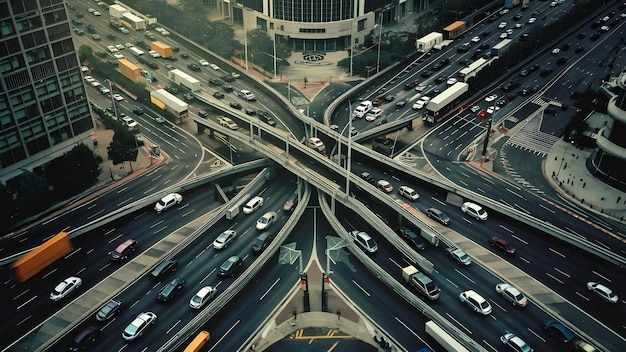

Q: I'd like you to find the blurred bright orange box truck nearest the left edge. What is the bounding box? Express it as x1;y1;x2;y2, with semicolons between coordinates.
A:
11;232;74;282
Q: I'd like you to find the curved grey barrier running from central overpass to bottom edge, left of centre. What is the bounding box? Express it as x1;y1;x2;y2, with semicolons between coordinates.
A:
157;183;311;351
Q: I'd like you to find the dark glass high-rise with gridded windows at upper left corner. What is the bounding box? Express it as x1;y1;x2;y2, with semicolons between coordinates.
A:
0;0;94;182
